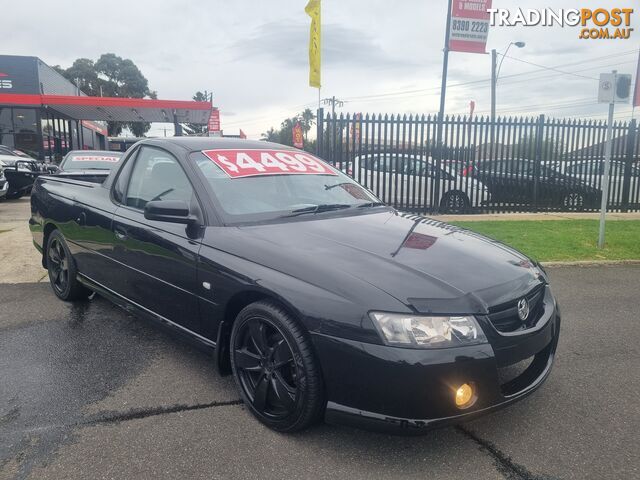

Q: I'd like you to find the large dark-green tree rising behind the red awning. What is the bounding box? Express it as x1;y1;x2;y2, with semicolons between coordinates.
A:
54;53;158;137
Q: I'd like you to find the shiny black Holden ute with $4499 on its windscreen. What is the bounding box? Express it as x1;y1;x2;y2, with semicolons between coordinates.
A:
29;138;560;433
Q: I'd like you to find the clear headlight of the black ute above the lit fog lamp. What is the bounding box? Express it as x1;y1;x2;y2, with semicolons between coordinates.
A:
370;312;487;348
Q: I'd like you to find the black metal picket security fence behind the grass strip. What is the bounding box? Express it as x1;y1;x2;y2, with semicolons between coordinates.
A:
317;109;640;213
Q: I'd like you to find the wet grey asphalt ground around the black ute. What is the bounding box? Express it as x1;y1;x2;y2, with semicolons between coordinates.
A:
0;197;640;480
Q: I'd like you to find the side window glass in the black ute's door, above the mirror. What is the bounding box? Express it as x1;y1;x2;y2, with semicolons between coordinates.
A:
124;146;193;210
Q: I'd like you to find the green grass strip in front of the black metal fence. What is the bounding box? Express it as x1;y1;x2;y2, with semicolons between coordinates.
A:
450;220;640;262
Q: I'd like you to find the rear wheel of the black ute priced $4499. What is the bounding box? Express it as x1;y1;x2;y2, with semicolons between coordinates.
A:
46;230;91;301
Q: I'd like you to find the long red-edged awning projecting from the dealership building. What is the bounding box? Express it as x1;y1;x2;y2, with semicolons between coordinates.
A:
0;93;211;124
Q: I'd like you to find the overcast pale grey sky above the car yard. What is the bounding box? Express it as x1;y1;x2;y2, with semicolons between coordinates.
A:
1;0;640;138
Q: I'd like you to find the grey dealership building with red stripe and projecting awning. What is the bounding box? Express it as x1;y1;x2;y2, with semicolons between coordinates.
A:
0;55;212;160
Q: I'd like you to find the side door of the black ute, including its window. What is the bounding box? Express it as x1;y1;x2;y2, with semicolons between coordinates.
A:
107;145;202;332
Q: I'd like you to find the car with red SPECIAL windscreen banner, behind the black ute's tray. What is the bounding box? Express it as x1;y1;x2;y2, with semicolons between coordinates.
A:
57;150;123;183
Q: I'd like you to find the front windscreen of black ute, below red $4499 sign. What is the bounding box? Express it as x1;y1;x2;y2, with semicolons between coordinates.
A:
191;151;379;224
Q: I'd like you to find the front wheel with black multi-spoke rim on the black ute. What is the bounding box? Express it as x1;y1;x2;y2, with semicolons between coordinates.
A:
230;301;324;432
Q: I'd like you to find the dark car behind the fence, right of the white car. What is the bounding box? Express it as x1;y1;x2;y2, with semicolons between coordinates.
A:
462;159;601;210
